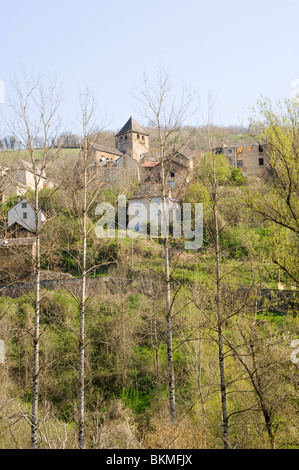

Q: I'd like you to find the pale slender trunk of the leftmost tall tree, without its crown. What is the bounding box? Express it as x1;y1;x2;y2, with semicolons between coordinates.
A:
31;182;40;449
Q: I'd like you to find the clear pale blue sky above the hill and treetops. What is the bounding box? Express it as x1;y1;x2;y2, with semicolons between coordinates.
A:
0;0;299;130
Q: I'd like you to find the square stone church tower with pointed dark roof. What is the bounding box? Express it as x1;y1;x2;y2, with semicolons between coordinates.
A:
115;116;149;162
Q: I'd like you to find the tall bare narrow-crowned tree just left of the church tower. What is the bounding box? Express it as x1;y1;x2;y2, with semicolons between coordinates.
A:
61;88;116;449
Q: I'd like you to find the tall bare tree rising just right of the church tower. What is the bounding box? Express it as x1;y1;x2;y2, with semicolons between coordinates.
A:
138;68;193;424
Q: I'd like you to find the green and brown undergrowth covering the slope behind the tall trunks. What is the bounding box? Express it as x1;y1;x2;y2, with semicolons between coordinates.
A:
0;149;299;448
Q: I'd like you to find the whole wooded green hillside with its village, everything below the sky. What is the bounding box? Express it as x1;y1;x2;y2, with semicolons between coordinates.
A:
0;104;299;449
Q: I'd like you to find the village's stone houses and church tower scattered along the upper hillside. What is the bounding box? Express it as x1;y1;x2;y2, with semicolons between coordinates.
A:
0;117;269;281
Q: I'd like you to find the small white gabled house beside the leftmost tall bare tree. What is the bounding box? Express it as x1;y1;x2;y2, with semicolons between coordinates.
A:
8;199;46;232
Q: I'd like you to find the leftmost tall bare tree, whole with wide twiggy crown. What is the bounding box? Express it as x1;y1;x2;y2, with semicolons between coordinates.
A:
0;71;61;449
